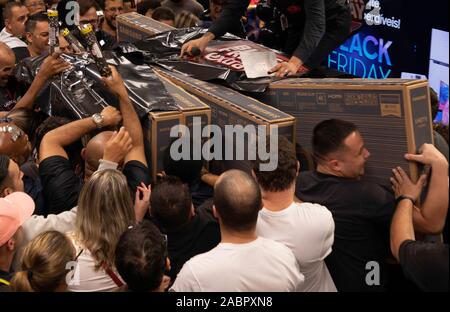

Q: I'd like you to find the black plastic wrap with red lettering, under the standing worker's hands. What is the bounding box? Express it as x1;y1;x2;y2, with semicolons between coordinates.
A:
117;27;288;92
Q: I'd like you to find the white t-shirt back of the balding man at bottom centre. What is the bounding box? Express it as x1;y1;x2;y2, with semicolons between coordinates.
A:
173;237;304;292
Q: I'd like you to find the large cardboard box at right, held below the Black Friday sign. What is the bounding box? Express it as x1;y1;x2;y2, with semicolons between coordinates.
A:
259;79;433;185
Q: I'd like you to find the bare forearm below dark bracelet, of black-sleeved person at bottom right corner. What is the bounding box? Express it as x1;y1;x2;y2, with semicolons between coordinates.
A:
391;199;415;260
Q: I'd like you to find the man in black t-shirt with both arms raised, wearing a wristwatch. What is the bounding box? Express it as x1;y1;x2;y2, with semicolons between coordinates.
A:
39;68;151;214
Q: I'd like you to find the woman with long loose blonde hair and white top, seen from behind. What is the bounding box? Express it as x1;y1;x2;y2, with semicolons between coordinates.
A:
69;169;136;291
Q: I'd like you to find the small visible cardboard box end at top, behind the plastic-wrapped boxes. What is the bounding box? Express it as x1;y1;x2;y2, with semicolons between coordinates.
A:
116;12;175;43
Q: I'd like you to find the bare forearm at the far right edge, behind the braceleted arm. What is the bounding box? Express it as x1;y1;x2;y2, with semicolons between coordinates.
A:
414;162;449;234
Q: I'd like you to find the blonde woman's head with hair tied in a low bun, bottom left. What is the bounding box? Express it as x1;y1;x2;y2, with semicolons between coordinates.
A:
11;231;75;292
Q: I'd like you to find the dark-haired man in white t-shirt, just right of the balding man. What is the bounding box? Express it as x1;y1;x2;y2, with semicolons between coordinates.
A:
253;137;336;292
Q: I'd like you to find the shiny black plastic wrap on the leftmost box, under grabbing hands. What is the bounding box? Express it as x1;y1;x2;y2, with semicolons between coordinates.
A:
15;54;178;119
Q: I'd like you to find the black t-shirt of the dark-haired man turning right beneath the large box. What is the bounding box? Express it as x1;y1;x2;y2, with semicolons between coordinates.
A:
296;171;394;291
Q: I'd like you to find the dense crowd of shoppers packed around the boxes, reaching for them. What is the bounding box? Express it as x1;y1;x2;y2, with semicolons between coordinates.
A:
0;0;449;292
